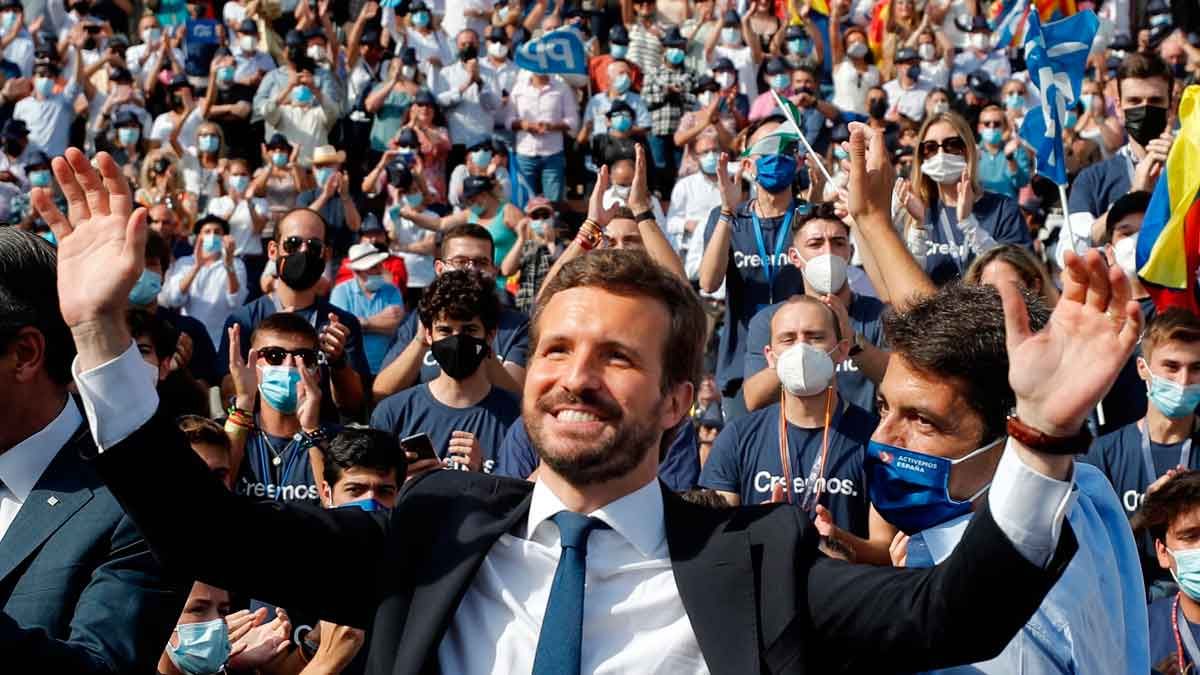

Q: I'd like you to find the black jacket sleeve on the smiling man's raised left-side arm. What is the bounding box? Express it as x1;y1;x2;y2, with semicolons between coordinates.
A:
95;413;395;627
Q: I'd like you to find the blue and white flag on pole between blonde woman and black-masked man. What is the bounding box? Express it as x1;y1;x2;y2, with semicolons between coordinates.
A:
1021;11;1100;185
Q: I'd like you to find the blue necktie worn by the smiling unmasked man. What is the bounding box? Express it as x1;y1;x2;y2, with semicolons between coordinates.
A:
533;510;608;675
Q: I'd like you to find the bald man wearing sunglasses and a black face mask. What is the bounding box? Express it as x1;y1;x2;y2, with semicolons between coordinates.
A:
217;209;371;422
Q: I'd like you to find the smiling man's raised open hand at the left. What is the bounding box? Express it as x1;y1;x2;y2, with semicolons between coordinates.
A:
30;148;146;370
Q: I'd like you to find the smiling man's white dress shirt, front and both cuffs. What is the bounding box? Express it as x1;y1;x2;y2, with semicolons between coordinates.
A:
82;342;1074;674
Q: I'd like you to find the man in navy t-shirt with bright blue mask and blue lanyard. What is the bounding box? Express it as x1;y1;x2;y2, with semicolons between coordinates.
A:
700;115;804;419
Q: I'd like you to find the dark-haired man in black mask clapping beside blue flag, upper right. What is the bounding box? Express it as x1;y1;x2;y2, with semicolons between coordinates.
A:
1069;52;1175;231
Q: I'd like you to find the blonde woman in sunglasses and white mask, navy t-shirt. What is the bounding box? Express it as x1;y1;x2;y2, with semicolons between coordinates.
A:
901;112;1033;285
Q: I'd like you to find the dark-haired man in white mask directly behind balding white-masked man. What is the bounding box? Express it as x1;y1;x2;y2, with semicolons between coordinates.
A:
742;204;888;411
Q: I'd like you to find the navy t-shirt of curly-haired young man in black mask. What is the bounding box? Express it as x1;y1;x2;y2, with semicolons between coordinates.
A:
371;384;521;473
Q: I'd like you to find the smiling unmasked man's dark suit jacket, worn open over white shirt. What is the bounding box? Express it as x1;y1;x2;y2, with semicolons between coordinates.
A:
97;417;1076;675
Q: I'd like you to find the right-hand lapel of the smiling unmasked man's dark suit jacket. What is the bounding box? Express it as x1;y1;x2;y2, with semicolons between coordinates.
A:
664;489;760;675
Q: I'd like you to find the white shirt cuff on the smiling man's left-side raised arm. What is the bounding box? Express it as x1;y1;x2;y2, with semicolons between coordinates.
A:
71;342;158;452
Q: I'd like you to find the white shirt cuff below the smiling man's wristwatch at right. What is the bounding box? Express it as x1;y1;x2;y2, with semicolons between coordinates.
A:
988;438;1076;567
